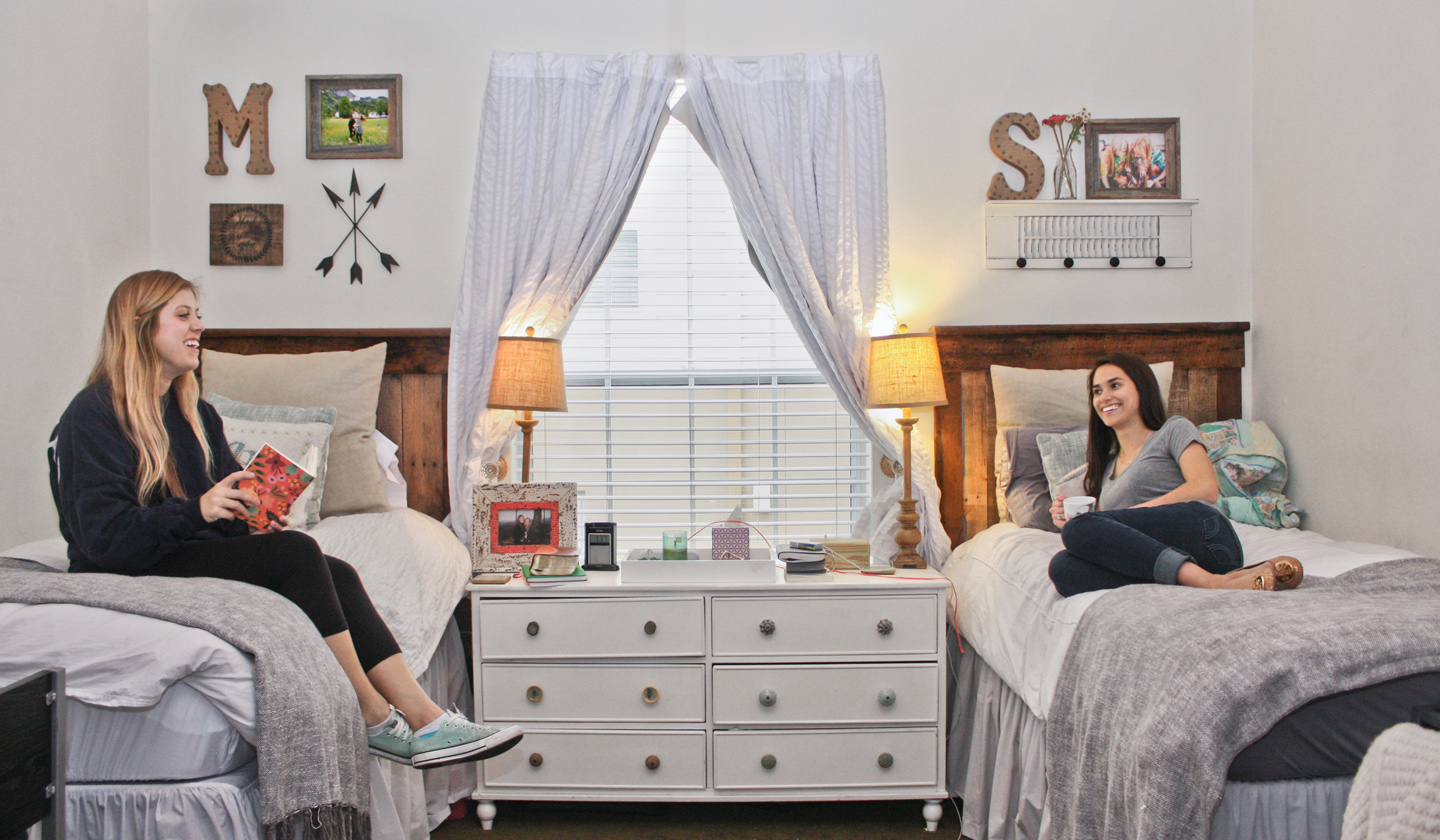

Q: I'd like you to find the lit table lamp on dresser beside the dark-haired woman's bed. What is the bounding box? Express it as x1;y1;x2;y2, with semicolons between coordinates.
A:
865;324;949;569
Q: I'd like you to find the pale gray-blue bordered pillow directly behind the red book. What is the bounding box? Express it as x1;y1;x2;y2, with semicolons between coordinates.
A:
204;390;337;529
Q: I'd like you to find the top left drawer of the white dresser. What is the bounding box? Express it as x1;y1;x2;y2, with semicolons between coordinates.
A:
475;598;706;661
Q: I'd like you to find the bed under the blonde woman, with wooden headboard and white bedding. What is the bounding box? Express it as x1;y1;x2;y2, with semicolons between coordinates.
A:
0;330;475;840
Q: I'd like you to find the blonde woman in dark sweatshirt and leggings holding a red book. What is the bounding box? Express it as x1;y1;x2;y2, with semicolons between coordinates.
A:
50;271;521;768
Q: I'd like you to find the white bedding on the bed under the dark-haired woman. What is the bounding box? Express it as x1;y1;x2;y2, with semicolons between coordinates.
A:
943;523;1414;720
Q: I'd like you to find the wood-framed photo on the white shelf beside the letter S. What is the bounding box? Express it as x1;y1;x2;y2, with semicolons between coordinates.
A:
1084;117;1181;199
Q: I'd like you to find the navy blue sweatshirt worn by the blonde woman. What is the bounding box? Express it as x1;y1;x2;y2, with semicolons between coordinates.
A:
50;383;249;575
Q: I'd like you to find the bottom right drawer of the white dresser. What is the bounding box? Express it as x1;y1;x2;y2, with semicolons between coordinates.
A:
711;728;940;790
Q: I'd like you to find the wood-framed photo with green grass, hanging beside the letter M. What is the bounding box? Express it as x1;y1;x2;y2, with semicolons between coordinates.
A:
305;75;405;160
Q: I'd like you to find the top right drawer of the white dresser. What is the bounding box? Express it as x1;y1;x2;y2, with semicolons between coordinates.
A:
714;594;939;656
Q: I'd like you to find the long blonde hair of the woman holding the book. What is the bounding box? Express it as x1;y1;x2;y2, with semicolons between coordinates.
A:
88;271;213;504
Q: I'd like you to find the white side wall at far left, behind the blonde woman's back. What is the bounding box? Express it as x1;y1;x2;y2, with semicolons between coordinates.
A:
0;0;150;548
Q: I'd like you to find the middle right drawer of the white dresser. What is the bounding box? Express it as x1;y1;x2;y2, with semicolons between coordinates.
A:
714;663;940;725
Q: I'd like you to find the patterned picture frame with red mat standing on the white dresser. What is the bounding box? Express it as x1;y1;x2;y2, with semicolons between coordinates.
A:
469;481;576;573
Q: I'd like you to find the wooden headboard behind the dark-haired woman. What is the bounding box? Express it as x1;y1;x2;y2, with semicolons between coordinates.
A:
935;321;1250;545
